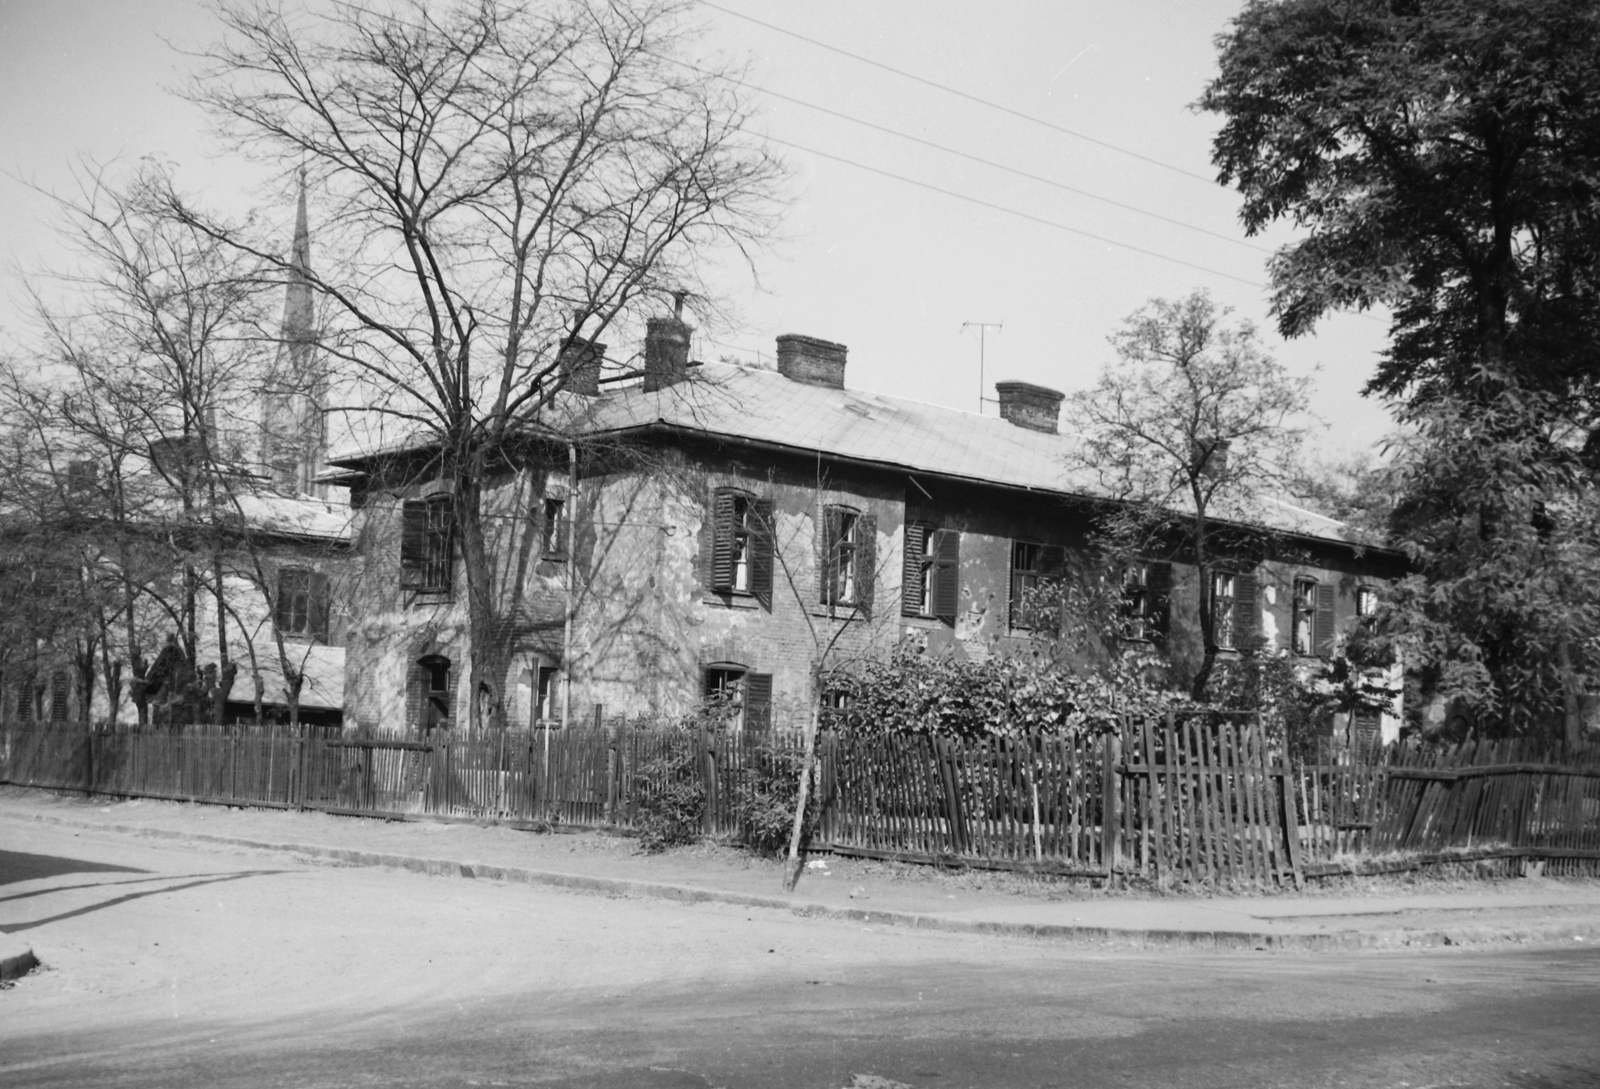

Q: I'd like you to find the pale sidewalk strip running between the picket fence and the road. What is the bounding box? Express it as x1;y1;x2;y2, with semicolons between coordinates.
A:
0;787;1600;958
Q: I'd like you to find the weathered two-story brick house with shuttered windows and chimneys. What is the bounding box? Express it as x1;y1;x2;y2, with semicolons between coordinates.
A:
326;318;1402;729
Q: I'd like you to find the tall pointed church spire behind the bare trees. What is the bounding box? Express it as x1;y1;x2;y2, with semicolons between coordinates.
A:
261;170;328;497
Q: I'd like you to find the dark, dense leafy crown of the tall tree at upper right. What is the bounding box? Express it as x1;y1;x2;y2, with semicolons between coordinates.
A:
1198;0;1600;413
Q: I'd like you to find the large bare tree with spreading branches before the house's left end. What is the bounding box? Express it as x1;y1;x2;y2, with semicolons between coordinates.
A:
173;0;781;724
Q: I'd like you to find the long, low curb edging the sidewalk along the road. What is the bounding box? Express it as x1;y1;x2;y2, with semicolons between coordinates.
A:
12;814;1600;953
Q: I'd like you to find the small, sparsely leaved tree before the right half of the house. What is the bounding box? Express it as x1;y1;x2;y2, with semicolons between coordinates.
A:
1067;291;1307;702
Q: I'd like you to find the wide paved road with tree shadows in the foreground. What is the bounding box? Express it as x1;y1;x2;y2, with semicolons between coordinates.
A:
0;822;1600;1089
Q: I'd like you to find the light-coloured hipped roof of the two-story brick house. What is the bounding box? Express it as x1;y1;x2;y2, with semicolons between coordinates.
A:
326;363;1346;542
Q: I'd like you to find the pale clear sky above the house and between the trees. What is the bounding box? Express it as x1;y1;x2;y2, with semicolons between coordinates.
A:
0;0;1389;457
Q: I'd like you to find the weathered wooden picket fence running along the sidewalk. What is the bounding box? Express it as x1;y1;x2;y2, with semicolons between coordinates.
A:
0;715;1600;884
